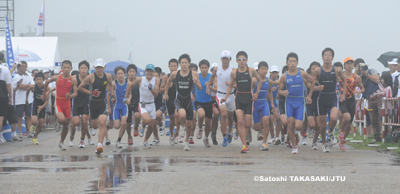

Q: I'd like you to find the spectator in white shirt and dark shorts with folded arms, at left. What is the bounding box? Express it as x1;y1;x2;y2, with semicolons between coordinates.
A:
13;61;34;138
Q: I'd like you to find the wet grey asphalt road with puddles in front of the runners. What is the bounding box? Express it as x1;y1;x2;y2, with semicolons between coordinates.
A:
0;129;400;193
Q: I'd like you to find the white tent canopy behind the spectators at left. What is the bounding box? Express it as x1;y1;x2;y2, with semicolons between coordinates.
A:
0;37;60;69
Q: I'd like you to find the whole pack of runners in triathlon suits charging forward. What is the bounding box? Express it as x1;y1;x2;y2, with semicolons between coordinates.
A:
27;48;364;154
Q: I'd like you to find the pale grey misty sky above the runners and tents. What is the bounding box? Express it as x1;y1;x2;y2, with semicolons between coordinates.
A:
15;0;400;72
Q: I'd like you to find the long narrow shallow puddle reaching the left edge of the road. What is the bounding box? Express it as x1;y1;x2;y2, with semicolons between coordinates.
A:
1;155;94;162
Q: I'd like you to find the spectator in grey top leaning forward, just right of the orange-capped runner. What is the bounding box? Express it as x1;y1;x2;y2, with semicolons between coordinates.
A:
359;63;385;143
